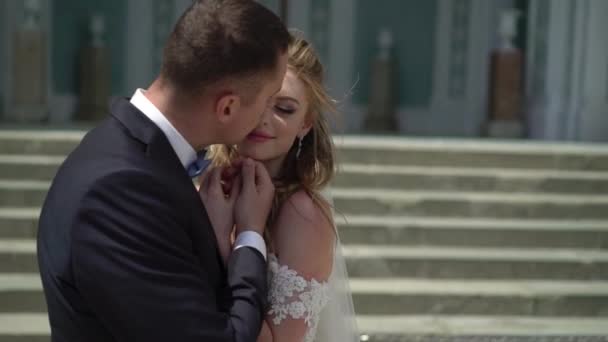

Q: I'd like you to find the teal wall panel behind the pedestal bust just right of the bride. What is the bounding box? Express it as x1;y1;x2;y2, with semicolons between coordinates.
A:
354;0;436;106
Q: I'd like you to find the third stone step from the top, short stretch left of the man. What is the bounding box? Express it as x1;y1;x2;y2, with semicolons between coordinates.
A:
0;183;50;207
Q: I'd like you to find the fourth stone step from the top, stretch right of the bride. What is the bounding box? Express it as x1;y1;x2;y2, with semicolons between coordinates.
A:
336;215;608;249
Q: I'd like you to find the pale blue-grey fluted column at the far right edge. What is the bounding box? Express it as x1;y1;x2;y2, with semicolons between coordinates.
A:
526;0;608;141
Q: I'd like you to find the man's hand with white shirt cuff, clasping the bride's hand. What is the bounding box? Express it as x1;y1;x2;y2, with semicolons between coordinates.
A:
231;159;274;235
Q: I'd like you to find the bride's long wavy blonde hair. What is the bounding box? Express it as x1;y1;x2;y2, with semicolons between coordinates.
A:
210;32;337;246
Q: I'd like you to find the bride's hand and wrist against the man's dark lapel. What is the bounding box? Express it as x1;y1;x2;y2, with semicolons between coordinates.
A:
199;168;241;262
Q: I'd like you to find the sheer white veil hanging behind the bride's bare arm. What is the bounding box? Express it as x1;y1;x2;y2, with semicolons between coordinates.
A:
315;188;359;342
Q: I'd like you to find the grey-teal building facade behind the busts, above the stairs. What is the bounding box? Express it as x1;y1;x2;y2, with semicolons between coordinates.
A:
0;0;608;141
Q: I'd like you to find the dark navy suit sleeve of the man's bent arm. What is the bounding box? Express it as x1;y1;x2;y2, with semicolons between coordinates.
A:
72;172;267;342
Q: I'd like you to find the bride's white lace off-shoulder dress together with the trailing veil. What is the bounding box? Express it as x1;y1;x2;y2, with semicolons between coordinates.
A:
268;188;359;342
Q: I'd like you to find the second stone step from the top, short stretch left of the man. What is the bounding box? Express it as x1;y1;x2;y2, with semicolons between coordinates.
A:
0;154;65;181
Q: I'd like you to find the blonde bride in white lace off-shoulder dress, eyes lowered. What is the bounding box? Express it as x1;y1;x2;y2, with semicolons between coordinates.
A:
203;32;359;342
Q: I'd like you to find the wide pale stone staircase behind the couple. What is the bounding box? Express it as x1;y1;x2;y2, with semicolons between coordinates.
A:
0;130;608;342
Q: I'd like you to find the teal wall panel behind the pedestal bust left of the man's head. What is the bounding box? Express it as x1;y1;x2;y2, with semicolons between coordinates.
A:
51;0;128;95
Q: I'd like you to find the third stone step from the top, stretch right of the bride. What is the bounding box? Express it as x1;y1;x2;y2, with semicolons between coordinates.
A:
332;188;608;220
